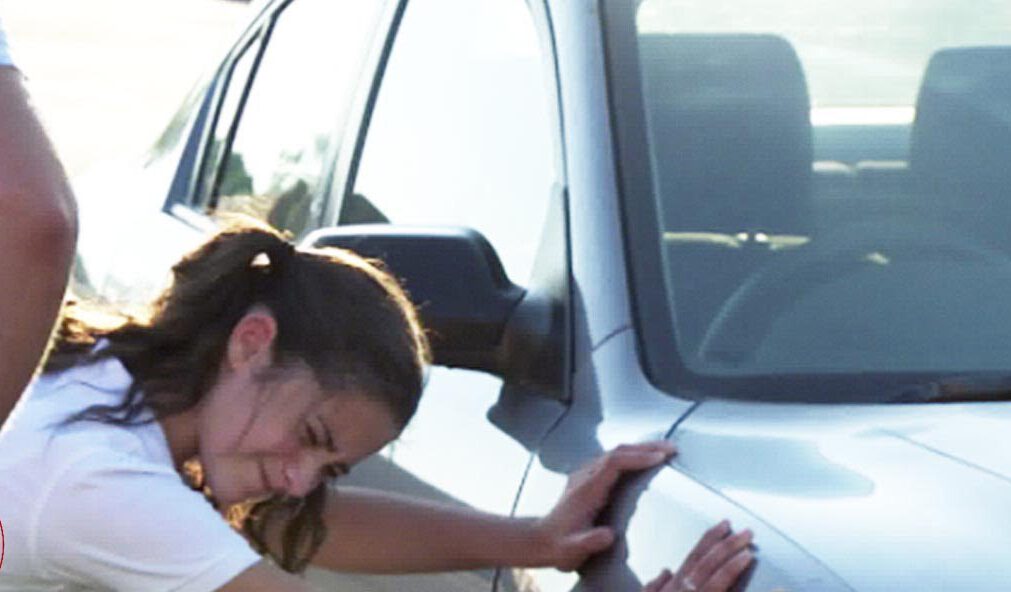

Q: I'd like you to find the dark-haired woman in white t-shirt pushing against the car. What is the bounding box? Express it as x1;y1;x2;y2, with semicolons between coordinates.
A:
0;222;750;591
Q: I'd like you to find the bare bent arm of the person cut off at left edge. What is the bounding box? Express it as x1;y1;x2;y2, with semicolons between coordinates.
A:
0;67;77;423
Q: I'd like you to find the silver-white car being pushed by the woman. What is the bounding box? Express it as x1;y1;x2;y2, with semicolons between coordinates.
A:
77;0;1011;592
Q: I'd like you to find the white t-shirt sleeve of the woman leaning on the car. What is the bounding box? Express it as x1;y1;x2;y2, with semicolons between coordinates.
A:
32;451;261;592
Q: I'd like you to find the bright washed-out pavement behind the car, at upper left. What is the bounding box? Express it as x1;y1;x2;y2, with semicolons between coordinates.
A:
0;0;252;177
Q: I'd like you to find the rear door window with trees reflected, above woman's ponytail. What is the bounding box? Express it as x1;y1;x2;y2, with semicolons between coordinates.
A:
204;0;385;236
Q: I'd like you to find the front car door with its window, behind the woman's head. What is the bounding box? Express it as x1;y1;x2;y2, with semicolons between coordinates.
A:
295;0;566;590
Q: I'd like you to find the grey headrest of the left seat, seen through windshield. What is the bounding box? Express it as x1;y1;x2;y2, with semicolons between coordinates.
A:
639;34;813;233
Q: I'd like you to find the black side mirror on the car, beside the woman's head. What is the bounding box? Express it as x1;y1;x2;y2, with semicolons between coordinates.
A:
302;224;564;396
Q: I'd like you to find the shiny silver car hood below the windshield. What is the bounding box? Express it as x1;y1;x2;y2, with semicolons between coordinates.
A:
674;401;1011;591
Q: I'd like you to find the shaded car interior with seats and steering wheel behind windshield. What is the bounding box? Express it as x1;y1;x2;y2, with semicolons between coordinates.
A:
639;33;1011;374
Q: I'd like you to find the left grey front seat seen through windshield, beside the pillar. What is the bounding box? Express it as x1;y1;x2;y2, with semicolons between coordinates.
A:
639;34;813;349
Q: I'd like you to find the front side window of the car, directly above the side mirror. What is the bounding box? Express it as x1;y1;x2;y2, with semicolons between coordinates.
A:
339;0;558;282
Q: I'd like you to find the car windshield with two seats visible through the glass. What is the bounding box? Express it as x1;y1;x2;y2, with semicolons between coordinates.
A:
604;0;1011;400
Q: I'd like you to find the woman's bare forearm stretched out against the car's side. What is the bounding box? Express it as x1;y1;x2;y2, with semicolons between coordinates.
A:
312;488;550;573
